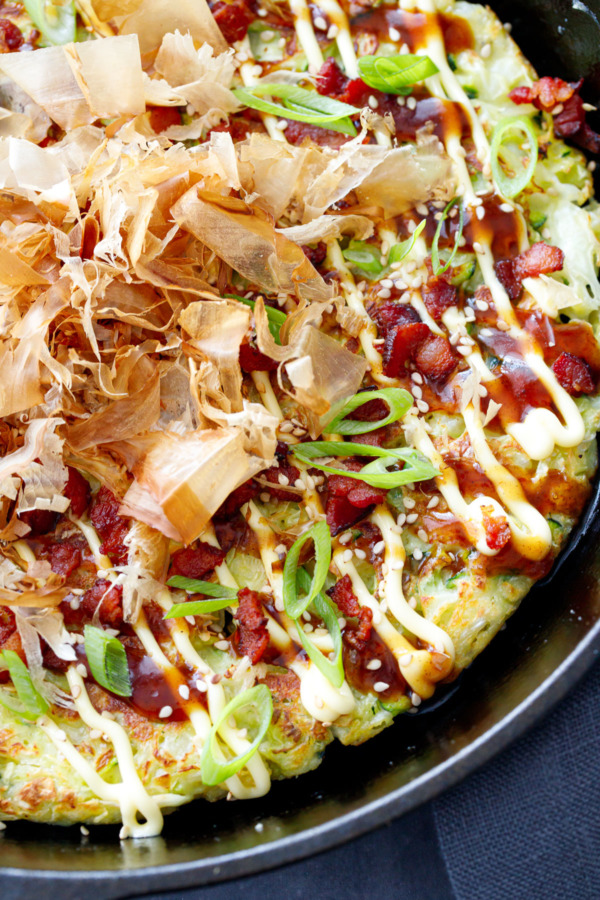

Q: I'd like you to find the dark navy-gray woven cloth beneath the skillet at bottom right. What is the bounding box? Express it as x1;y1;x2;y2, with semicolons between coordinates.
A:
138;664;600;900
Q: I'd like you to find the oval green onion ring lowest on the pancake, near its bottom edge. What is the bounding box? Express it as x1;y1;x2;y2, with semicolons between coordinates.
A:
201;684;273;786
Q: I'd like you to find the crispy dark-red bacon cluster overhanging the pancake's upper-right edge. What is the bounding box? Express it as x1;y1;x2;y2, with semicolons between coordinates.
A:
508;76;600;153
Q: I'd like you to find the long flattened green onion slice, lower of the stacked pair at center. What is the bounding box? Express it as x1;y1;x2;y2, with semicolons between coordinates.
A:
292;441;440;488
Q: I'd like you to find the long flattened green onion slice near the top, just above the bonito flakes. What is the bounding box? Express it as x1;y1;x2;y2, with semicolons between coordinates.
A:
233;82;360;135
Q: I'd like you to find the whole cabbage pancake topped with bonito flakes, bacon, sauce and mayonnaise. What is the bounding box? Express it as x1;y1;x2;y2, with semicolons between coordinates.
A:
0;0;600;837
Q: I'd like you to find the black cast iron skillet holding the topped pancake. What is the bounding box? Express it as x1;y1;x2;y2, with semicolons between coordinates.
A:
0;0;600;900
